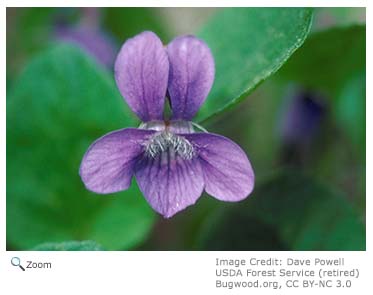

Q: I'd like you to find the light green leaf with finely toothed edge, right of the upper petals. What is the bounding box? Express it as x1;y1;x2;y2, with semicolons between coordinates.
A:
198;8;312;120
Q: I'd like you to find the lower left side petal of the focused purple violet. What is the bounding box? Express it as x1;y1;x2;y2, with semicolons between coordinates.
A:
79;128;154;194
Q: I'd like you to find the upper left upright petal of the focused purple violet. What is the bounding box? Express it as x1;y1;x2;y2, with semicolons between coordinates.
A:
115;32;169;122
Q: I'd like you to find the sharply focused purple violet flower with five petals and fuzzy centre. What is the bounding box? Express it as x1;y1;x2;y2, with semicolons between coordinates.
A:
80;32;254;218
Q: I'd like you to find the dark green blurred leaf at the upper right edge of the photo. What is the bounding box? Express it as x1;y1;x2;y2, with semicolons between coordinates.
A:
277;26;366;98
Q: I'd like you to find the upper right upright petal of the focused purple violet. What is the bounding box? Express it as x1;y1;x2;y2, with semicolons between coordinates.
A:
167;36;215;120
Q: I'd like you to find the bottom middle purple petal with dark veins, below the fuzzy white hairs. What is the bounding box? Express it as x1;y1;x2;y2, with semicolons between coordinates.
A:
135;151;203;218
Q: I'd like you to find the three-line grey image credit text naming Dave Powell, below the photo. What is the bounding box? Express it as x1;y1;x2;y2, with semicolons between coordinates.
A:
215;257;360;289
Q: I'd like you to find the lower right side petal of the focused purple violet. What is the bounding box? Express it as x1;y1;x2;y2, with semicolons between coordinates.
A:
184;133;254;202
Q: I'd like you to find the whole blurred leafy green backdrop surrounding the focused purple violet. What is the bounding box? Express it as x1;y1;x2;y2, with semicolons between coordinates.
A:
6;8;366;250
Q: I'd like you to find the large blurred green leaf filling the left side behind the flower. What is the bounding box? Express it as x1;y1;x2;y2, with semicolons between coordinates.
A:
7;45;155;250
